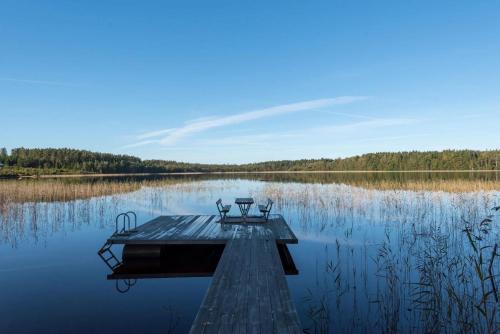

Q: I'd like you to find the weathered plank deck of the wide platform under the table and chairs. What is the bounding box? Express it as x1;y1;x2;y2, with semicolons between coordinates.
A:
108;215;298;245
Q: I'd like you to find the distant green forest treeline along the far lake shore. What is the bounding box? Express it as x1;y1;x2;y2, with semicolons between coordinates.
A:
0;148;500;174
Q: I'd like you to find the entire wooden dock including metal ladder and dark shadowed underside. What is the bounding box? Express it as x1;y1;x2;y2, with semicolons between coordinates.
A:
99;215;302;333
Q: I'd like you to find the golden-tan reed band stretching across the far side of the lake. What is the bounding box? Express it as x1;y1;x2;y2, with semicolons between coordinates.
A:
0;175;500;207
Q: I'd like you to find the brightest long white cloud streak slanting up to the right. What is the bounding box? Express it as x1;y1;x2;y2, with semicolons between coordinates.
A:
129;96;368;147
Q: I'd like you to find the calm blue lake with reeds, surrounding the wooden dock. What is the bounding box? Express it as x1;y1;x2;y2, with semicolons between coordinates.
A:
0;173;500;333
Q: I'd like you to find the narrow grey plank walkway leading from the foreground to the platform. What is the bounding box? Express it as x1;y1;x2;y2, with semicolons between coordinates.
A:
190;236;302;334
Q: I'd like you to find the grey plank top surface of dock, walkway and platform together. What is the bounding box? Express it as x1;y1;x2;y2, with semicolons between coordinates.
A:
108;215;302;333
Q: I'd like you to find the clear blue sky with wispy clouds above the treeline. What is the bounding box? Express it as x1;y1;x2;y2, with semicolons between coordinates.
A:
0;0;500;163
